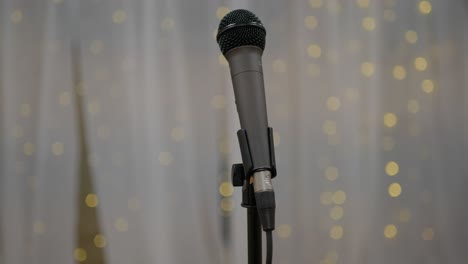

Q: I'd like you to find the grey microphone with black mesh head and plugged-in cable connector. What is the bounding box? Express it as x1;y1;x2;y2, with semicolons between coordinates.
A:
216;9;276;231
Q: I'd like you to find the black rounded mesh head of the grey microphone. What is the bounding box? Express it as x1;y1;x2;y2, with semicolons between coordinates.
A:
216;9;266;54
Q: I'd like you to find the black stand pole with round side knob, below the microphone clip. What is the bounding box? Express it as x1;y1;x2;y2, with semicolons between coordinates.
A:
232;164;262;264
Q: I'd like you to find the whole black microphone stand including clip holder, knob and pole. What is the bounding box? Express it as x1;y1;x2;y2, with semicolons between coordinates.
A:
231;127;276;264
